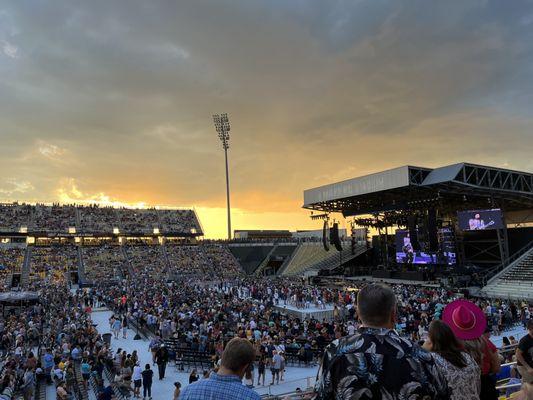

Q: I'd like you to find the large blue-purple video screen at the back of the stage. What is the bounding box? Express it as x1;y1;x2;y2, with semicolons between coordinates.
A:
396;228;456;265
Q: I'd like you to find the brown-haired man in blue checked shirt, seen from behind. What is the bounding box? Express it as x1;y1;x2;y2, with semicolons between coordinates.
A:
180;338;261;400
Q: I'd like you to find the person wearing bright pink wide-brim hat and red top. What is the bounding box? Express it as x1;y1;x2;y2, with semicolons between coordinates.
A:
442;299;500;400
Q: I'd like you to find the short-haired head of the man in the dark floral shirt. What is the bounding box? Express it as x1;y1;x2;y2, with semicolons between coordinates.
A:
357;284;396;327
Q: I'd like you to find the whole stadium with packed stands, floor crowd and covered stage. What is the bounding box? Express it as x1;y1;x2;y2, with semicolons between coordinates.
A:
0;163;533;399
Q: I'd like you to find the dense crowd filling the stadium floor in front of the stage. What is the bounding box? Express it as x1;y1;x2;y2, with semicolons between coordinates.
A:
98;247;531;396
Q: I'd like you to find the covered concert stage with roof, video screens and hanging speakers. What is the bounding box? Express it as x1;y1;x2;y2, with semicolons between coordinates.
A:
303;162;533;272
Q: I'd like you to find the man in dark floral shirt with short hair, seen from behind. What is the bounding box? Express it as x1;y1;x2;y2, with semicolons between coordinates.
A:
316;285;450;400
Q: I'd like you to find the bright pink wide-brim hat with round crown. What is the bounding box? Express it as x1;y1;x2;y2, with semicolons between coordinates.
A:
442;299;487;340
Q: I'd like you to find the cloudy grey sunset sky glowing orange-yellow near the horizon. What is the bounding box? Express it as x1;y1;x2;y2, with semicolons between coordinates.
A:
0;0;533;238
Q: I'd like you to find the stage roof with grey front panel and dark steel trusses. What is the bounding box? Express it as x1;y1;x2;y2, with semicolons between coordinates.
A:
303;162;533;216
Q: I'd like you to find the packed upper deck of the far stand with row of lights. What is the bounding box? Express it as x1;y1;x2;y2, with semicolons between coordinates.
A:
0;203;203;237
